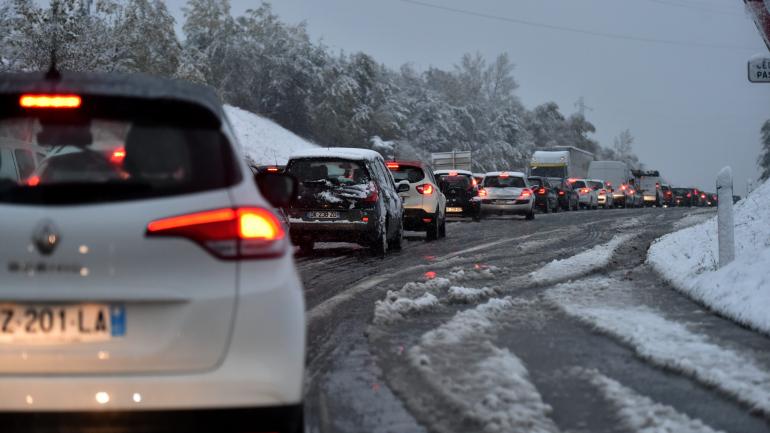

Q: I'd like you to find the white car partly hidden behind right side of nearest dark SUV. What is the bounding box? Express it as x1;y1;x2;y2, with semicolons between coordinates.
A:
386;161;446;240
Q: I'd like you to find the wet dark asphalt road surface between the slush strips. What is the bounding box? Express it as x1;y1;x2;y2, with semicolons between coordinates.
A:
296;208;770;433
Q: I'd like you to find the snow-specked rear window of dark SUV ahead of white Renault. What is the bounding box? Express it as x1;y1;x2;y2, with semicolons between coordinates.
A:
286;158;371;185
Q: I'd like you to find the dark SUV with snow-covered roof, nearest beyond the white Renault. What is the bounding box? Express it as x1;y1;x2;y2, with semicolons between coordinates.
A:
286;148;403;255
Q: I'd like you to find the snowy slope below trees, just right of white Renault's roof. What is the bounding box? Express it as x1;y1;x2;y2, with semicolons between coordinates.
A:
224;105;317;165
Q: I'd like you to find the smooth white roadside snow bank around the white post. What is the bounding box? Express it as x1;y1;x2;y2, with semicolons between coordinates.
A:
647;182;770;334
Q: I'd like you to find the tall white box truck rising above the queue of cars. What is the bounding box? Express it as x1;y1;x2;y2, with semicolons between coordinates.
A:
529;146;594;179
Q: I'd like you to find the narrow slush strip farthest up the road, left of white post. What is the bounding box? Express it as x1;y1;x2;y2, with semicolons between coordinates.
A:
530;233;636;284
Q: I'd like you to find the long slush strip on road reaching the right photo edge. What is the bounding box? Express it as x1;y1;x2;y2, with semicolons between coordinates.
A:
545;277;770;416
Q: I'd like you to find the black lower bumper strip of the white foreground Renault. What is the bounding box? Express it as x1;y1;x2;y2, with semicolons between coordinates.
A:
0;404;303;433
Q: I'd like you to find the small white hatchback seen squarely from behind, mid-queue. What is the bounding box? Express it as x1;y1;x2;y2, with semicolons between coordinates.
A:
479;171;535;220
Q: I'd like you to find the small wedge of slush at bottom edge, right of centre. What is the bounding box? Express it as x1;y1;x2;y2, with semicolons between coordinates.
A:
578;369;721;433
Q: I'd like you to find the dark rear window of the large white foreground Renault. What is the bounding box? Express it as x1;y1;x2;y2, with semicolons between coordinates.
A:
0;117;237;204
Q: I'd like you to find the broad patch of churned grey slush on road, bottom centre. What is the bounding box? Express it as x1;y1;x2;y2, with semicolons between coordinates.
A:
409;298;558;433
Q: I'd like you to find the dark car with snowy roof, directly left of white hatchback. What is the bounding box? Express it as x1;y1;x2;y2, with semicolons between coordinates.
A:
434;170;481;221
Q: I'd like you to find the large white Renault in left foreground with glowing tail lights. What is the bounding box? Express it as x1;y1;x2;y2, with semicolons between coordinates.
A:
0;72;306;432
